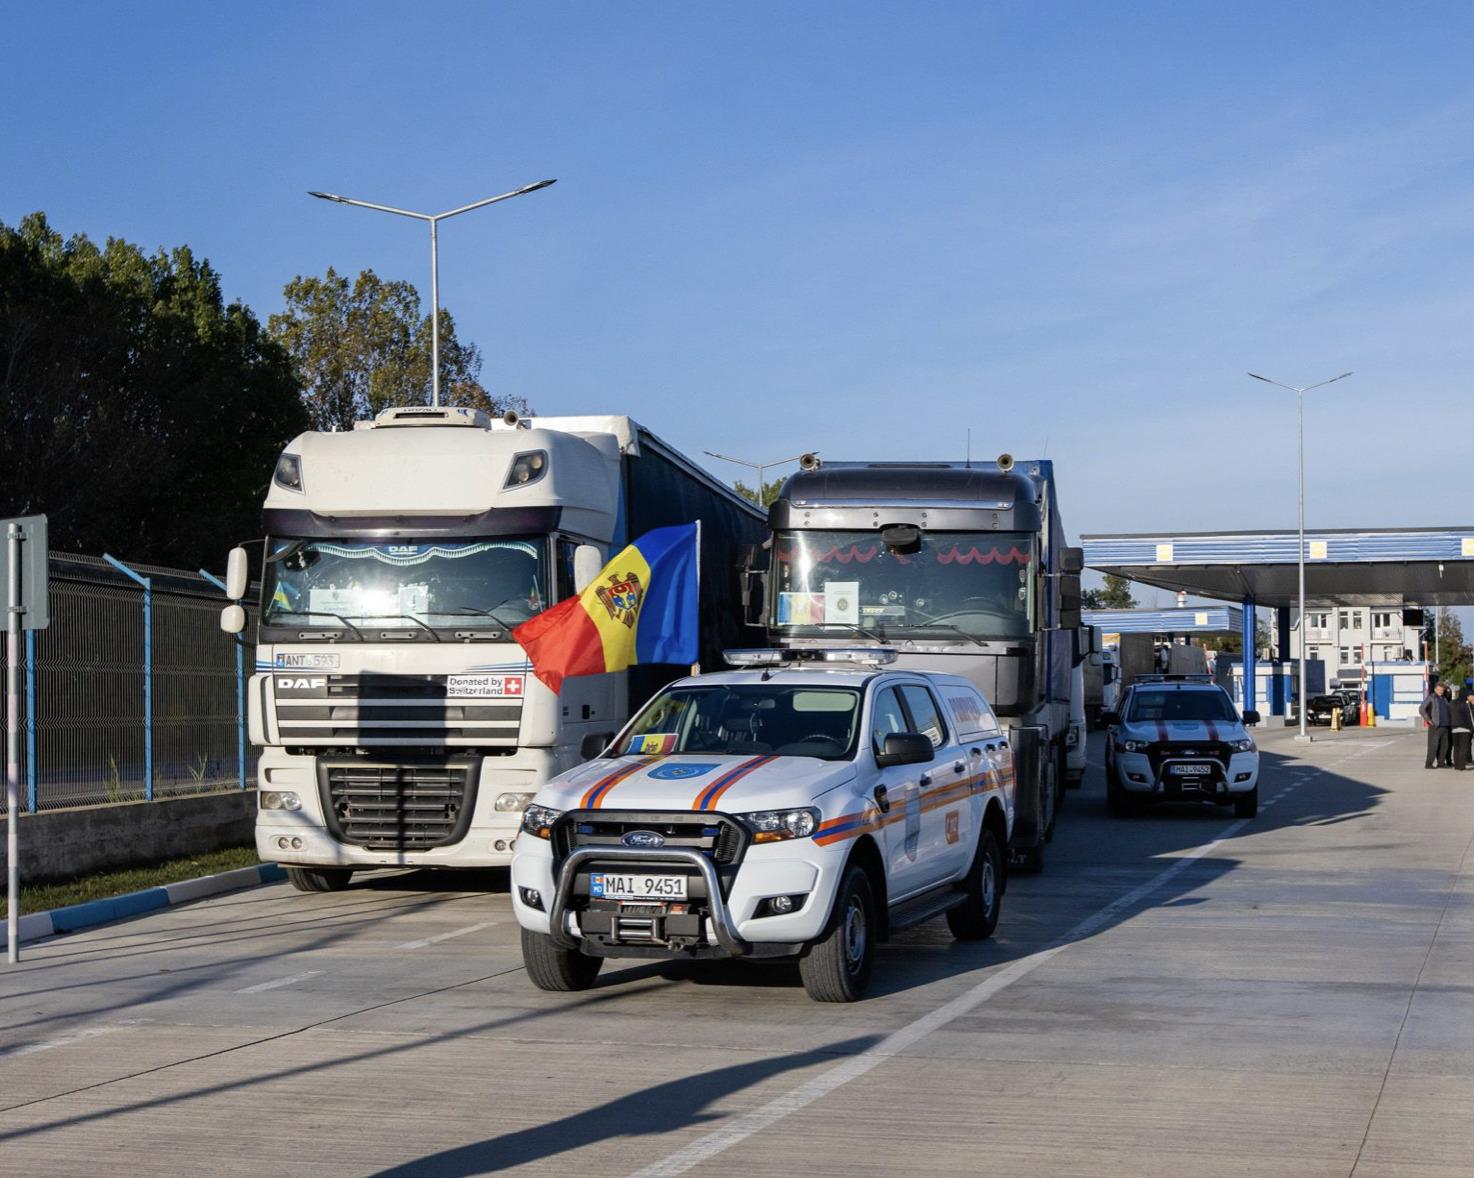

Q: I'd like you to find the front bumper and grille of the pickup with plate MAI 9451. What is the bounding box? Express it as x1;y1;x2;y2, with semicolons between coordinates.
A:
511;811;837;958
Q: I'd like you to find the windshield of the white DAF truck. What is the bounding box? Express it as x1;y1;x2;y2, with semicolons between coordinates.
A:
261;537;548;631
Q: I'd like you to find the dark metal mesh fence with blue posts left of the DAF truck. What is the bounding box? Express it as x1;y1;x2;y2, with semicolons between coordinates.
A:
0;553;255;814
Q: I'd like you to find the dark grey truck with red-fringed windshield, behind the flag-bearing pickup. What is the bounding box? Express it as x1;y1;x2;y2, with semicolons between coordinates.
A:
766;454;1082;870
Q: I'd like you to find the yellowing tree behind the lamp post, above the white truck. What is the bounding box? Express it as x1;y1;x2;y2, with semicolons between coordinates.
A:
267;267;528;429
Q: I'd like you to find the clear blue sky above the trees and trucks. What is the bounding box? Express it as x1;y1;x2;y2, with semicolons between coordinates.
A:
0;0;1474;566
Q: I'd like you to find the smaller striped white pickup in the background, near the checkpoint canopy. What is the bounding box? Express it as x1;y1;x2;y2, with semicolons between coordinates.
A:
1101;675;1259;818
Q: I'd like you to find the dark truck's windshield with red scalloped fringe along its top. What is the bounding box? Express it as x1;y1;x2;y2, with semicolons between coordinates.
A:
772;531;1033;638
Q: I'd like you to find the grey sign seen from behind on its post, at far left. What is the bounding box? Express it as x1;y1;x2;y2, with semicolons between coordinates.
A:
0;516;49;966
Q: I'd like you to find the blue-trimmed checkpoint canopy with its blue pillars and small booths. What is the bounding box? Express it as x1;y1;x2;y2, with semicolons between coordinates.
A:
1080;525;1474;722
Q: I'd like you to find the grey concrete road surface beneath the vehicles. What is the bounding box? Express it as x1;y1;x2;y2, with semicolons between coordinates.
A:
0;730;1474;1178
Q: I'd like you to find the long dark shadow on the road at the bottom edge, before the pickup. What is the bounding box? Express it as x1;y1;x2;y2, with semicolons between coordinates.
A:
374;1035;879;1178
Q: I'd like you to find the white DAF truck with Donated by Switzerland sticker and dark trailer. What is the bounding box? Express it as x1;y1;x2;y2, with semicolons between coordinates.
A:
221;408;764;891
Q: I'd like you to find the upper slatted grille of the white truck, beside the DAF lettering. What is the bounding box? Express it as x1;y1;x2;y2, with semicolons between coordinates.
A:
271;672;526;747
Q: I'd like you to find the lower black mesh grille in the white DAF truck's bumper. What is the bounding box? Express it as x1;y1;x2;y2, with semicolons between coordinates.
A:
318;761;476;851
